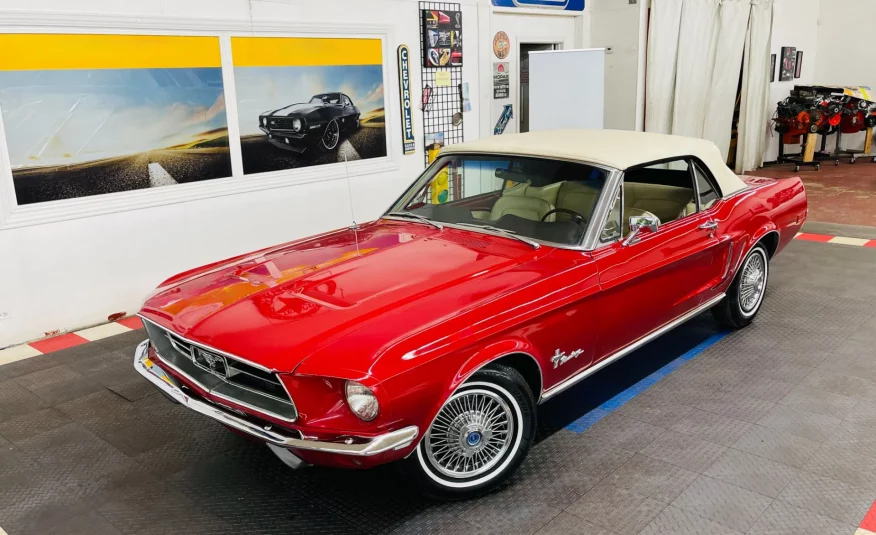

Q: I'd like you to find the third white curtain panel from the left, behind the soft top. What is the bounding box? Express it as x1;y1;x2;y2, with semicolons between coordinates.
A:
702;0;751;162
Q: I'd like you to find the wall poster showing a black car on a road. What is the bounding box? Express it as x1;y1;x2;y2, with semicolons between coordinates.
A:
231;37;386;174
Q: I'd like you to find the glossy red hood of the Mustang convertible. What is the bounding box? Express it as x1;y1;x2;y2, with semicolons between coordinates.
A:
141;220;548;373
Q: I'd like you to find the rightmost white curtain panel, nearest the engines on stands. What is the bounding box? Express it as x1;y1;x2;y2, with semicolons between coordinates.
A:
736;0;773;174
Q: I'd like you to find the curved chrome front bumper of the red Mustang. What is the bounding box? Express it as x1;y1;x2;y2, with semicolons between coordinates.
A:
134;340;419;457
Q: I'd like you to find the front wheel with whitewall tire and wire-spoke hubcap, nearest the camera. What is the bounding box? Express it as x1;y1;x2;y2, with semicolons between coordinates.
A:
402;365;536;500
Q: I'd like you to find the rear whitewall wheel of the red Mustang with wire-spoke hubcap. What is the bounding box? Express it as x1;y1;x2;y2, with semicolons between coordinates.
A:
712;243;770;329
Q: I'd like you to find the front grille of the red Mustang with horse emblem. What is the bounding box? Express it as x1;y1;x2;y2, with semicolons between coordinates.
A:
143;320;298;421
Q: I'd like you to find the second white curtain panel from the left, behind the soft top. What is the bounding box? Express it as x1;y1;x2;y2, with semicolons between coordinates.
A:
672;0;720;137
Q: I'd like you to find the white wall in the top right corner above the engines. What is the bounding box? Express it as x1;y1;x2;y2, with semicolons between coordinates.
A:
815;0;876;153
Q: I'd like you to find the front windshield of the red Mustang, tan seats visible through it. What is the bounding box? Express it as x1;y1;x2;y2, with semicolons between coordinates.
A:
390;154;609;245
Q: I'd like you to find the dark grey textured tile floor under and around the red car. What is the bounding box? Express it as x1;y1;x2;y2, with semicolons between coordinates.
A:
0;241;876;535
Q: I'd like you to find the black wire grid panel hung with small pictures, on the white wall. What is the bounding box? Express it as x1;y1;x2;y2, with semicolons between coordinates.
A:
417;2;465;168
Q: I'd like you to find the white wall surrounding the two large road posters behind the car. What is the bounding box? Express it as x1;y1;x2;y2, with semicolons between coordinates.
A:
0;0;590;348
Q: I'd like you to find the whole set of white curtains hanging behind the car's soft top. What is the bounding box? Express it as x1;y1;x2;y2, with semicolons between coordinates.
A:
645;0;773;170
